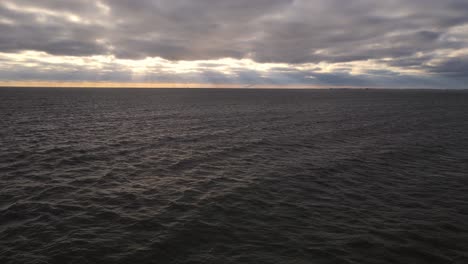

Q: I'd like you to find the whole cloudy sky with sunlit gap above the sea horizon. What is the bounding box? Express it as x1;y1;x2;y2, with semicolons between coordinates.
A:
0;0;468;89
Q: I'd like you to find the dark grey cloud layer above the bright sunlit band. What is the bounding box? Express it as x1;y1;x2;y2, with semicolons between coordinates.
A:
0;0;468;85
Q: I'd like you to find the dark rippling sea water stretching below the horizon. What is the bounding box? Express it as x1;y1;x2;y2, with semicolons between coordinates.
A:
0;89;468;264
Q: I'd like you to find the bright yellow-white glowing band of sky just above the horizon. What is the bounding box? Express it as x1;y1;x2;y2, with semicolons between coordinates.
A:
0;51;424;88
